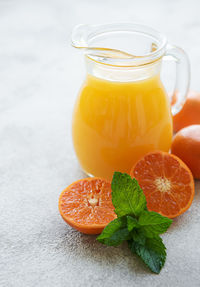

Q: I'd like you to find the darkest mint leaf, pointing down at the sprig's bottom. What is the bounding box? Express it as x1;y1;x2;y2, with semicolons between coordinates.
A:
129;237;166;273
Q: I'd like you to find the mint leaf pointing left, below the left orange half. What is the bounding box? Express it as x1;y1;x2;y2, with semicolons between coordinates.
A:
97;217;130;246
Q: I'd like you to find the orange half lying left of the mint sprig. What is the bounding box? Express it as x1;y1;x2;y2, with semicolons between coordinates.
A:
58;177;116;234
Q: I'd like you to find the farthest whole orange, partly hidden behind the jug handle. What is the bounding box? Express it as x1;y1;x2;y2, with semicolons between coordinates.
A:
173;91;200;132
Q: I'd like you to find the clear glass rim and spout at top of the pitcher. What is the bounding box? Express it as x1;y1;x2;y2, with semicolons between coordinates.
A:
72;22;167;68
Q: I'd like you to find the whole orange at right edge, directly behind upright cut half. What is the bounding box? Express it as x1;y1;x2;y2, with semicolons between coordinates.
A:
171;125;200;179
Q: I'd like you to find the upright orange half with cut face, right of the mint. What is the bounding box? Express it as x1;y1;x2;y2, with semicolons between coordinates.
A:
130;151;194;218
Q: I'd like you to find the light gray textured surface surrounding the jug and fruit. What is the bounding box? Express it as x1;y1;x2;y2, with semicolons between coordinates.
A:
0;0;200;287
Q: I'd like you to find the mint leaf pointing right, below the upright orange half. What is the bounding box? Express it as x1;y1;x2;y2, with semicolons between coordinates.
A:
138;211;172;238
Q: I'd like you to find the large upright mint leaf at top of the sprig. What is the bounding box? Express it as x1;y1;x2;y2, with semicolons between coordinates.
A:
111;172;146;217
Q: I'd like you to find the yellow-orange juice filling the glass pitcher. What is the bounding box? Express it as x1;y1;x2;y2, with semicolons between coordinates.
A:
72;75;172;179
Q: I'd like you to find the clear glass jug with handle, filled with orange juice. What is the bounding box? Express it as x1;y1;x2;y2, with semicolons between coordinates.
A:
72;24;189;180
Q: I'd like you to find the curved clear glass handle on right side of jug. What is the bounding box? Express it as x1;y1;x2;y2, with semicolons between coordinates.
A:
164;45;190;116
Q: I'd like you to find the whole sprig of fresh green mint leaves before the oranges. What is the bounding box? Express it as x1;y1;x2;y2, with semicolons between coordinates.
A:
97;172;172;273
